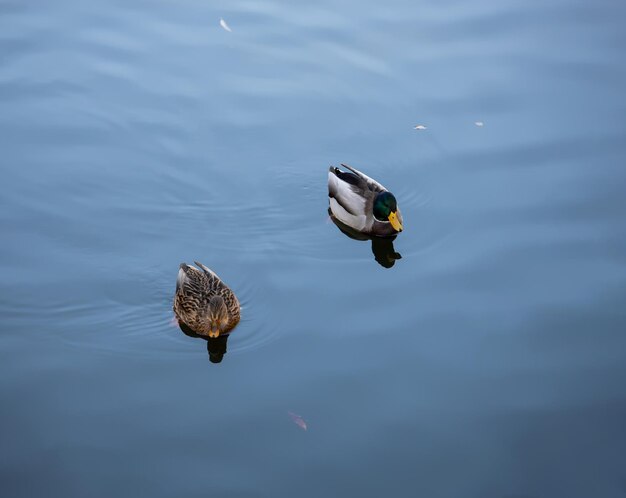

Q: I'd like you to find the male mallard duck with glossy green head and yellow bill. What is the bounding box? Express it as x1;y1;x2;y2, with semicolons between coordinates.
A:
328;164;402;237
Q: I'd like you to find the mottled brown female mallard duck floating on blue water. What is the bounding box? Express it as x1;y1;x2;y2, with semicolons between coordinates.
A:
174;261;241;337
